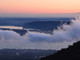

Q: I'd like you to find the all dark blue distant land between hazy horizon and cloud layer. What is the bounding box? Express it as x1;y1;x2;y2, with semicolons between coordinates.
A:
0;18;75;36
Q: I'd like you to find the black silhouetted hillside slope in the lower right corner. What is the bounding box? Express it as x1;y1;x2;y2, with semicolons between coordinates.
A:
40;41;80;60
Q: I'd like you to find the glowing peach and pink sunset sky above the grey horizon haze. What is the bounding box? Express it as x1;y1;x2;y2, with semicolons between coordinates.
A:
0;0;80;16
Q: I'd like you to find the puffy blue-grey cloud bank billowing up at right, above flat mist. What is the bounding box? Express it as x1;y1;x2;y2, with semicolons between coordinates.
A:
28;19;80;43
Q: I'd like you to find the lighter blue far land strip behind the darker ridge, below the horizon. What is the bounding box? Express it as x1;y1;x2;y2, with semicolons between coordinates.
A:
0;18;75;26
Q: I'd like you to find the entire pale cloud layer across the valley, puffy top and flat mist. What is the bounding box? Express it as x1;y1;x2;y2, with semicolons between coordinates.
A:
0;19;80;49
